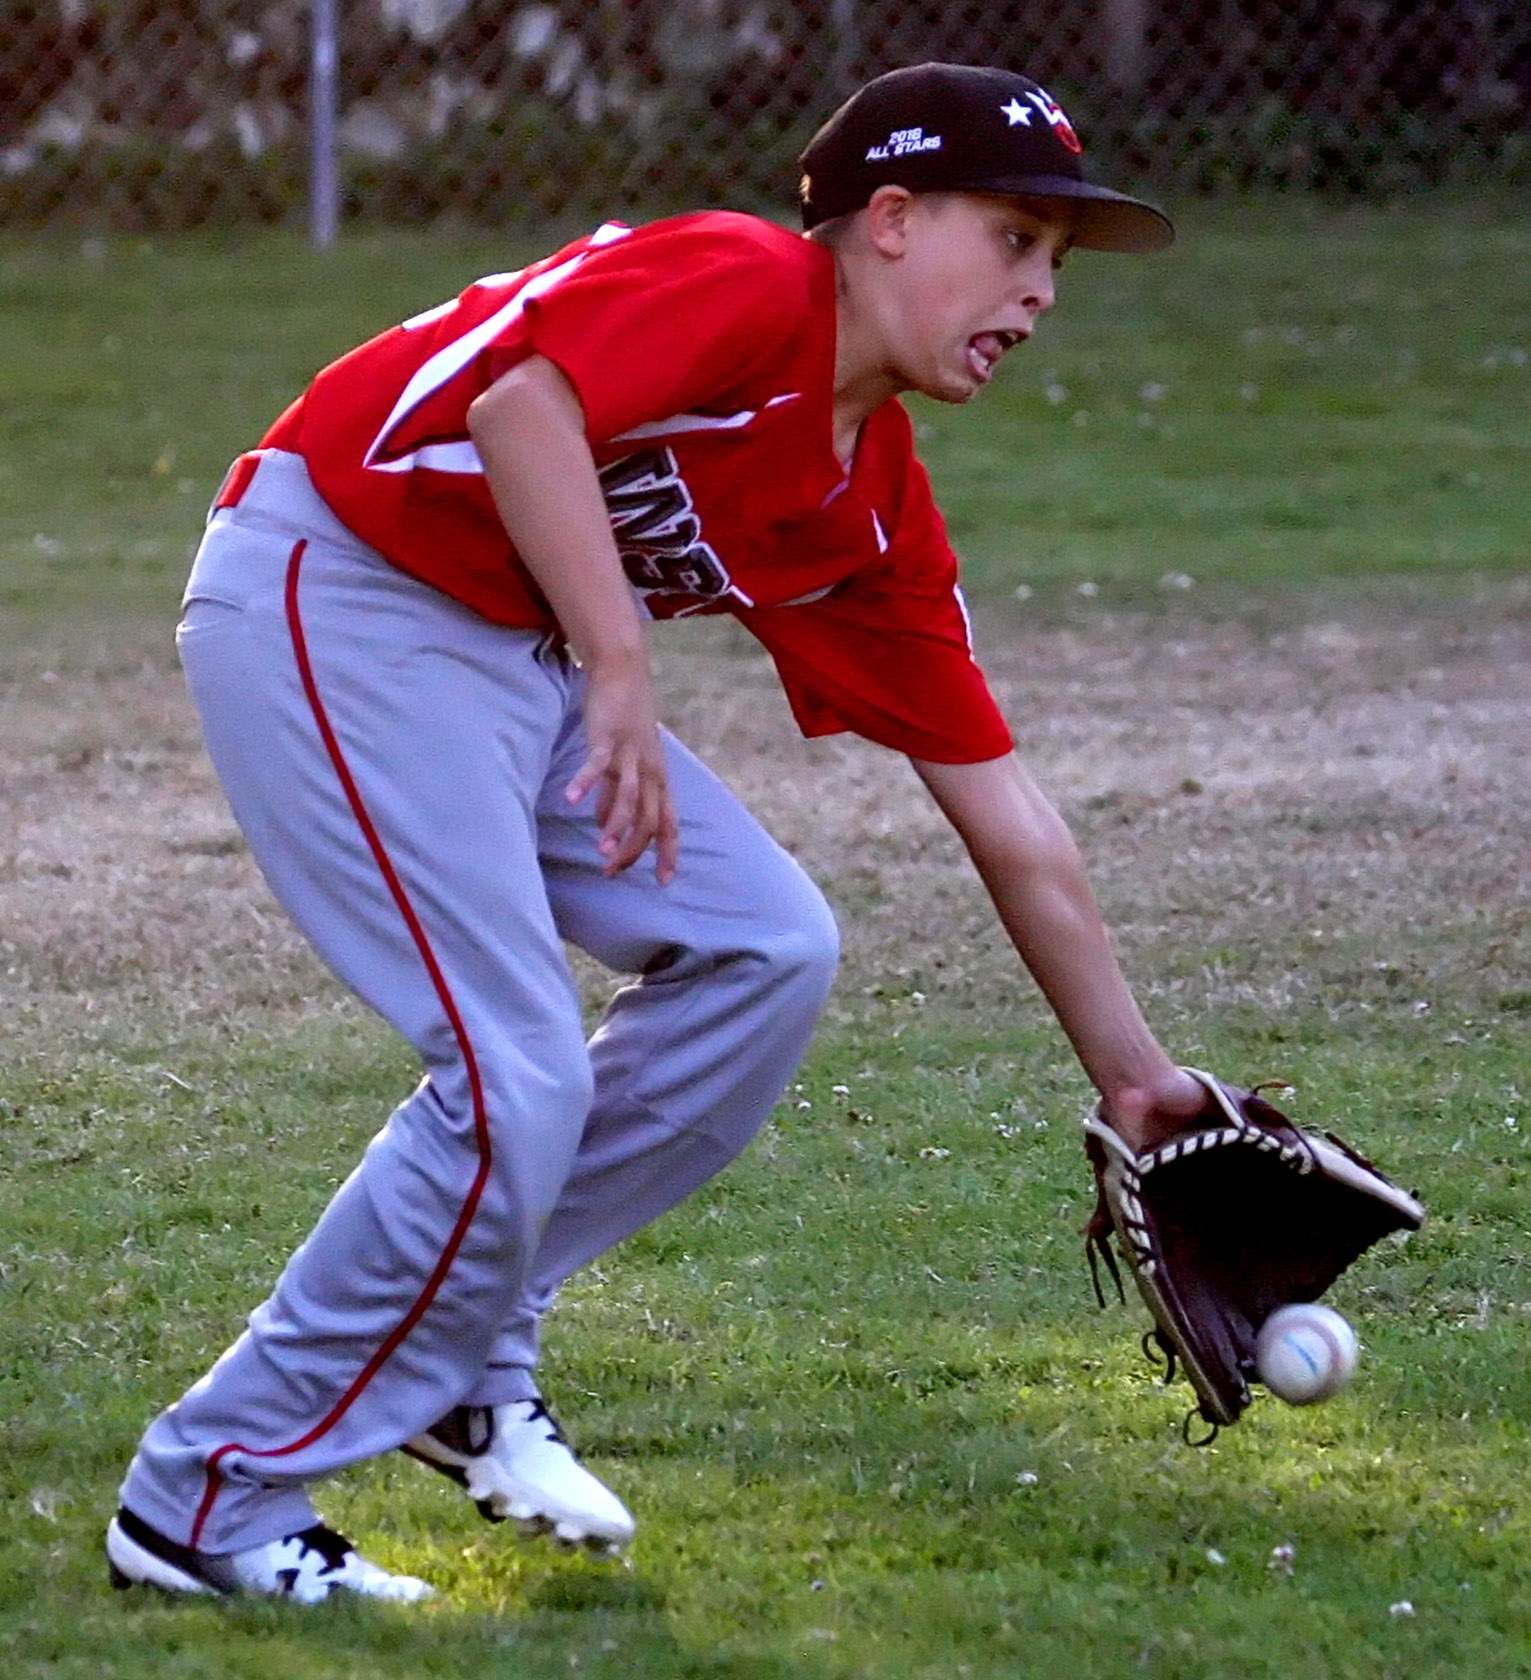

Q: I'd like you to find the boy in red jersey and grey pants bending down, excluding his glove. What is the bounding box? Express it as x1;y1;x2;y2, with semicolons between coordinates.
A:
106;64;1205;1601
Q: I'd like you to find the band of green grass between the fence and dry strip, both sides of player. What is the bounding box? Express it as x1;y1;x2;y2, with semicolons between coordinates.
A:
0;200;1531;638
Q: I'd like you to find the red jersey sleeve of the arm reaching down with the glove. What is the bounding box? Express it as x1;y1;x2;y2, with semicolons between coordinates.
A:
738;436;1015;764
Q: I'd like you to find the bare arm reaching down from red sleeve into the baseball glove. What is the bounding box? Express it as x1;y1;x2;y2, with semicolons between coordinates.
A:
913;754;1205;1147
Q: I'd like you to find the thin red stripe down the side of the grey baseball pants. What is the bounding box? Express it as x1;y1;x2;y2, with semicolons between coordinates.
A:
192;539;491;1547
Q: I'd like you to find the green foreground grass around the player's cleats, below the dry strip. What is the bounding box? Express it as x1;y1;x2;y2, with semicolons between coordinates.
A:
0;1001;1531;1680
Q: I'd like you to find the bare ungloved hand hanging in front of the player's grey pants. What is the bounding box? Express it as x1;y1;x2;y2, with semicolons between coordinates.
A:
565;660;679;887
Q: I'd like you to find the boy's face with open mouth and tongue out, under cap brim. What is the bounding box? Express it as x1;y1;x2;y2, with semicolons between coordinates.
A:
889;193;1069;403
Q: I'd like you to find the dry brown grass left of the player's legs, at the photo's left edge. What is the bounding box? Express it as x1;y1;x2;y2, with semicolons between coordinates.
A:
0;631;326;1048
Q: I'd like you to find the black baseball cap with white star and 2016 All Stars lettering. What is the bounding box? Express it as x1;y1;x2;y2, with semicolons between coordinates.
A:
798;64;1175;252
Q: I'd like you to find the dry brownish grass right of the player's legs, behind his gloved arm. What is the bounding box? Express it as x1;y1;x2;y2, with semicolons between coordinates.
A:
681;590;1531;1034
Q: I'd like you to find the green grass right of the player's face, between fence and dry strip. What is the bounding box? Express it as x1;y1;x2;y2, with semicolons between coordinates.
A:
923;205;1531;588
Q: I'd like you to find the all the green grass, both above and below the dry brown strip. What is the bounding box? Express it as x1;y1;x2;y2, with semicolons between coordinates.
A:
0;205;1531;1680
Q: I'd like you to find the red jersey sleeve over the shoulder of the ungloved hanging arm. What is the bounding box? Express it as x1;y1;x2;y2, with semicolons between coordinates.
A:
510;213;817;444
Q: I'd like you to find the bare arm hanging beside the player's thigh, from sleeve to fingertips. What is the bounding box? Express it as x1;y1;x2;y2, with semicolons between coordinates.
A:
467;356;676;882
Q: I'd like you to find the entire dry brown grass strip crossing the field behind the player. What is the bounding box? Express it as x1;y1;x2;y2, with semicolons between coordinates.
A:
0;590;1531;1055
